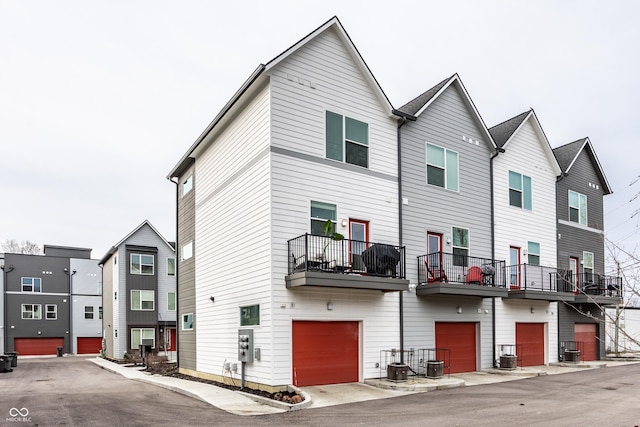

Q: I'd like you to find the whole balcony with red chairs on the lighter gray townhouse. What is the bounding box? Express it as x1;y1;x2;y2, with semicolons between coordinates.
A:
416;252;508;297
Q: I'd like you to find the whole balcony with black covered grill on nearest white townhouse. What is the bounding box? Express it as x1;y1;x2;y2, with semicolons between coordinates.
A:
285;234;409;292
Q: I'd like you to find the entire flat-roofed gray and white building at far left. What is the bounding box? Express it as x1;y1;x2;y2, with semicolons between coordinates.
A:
2;245;102;355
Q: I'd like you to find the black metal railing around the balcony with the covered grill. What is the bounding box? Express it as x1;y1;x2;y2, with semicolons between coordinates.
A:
288;234;405;279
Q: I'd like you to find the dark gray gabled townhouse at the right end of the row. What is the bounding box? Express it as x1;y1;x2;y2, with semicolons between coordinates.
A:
553;138;622;360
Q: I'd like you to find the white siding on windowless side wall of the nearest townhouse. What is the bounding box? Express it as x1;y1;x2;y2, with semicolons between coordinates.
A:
194;83;271;382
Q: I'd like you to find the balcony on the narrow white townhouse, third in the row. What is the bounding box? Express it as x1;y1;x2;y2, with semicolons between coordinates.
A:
506;264;575;302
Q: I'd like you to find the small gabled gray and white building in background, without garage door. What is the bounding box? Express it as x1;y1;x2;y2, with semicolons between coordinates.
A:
100;221;177;358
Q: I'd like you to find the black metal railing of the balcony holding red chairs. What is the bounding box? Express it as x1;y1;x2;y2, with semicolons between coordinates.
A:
418;252;506;288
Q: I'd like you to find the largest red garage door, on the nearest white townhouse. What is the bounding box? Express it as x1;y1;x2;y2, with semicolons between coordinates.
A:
292;321;358;386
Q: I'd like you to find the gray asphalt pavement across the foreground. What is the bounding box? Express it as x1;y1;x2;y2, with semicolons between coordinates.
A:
0;356;640;426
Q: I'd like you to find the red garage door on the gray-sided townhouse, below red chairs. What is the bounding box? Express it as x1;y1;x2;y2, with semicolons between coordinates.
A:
436;322;477;374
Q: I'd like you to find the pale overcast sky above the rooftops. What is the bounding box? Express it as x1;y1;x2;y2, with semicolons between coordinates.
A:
0;0;640;270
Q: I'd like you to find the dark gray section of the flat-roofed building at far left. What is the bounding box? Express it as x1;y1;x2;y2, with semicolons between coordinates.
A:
3;245;95;355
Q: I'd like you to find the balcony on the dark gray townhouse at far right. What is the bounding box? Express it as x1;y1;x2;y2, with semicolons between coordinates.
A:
563;271;622;304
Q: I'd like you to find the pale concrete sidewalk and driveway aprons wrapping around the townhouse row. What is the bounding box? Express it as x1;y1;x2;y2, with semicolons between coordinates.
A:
87;357;640;415
